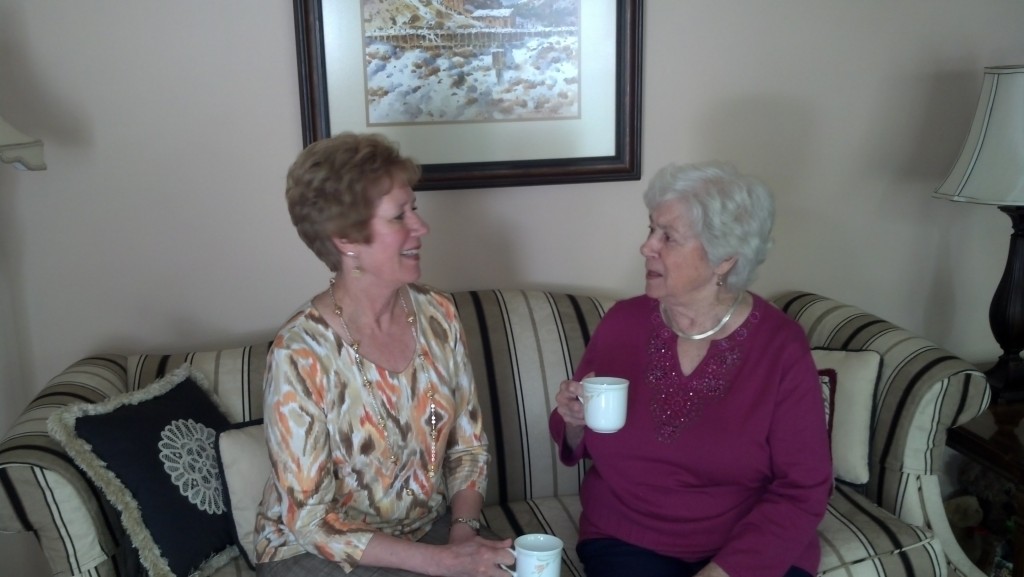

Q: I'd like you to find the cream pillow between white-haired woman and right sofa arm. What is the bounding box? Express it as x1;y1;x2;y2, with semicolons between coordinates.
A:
811;348;882;485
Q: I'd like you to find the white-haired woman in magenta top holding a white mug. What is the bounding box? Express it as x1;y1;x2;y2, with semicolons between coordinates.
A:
550;163;833;577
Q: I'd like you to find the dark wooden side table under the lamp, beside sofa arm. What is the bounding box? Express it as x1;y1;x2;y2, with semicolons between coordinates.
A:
946;403;1024;577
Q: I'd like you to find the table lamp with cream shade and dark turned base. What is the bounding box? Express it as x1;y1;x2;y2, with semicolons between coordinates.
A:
934;65;1024;402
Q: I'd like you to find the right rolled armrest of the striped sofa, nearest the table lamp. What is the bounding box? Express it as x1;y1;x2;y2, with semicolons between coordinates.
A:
773;292;991;502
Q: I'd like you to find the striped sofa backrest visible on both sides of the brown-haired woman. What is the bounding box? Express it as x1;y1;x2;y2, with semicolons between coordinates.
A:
128;290;614;504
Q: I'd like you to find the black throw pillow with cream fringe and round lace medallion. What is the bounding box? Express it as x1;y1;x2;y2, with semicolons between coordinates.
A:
47;365;238;577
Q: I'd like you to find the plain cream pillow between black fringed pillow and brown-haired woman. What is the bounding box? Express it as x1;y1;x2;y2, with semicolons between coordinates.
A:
217;419;270;570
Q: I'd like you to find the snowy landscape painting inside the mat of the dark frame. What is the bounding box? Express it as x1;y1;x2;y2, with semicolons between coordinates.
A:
361;0;581;126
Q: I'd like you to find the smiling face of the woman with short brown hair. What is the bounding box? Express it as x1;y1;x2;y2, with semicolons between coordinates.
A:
338;178;430;287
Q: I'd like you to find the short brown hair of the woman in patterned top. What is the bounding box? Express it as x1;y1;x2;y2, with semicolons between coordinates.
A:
285;132;421;272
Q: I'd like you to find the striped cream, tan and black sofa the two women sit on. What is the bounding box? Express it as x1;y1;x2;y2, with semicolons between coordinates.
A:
0;290;989;577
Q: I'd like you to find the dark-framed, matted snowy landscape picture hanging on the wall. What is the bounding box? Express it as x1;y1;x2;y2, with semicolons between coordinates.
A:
294;0;643;190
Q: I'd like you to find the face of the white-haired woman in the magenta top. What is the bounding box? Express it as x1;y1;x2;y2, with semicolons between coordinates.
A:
640;201;731;304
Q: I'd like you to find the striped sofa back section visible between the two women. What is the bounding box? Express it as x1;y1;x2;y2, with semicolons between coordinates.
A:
453;290;614;505
